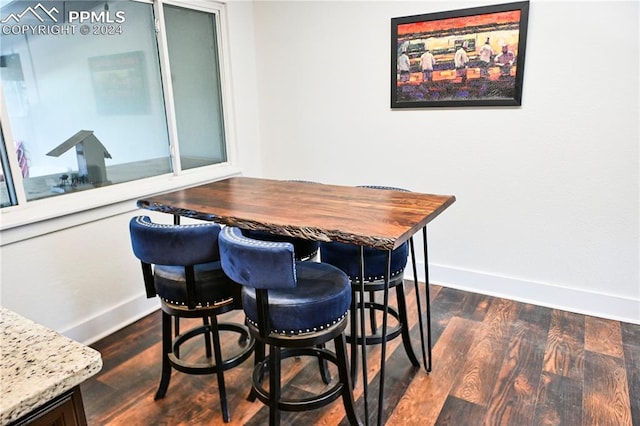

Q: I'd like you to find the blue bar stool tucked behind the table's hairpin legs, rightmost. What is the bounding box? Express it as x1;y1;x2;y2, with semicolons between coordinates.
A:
320;186;420;382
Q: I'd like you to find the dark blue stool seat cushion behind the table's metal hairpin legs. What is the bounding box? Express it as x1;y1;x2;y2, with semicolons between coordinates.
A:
320;242;409;281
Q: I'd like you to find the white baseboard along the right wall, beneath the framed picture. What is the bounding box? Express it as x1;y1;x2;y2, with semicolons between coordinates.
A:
405;263;640;324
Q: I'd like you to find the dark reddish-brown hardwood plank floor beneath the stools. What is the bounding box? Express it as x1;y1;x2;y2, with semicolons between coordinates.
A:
82;284;640;426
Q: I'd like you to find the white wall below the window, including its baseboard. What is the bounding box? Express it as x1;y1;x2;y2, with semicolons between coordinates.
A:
2;211;165;342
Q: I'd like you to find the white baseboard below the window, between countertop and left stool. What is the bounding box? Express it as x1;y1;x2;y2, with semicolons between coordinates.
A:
60;294;160;345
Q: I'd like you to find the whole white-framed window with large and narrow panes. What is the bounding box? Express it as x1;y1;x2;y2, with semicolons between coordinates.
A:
0;0;227;216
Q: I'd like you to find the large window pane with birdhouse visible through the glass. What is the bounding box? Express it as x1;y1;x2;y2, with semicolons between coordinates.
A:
0;1;171;201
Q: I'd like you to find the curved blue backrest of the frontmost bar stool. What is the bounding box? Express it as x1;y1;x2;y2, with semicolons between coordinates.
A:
218;226;296;289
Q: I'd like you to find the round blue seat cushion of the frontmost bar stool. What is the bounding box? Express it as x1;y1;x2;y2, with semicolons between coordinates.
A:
242;262;351;335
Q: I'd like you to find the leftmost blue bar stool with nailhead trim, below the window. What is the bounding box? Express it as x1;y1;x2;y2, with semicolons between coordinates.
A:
129;216;255;422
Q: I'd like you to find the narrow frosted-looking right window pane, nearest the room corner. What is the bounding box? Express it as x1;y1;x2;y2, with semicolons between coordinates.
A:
164;5;226;169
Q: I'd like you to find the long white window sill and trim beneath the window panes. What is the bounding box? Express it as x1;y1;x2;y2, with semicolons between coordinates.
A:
0;164;240;246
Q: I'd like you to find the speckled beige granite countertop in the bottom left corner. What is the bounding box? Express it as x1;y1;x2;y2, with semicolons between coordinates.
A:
0;306;102;425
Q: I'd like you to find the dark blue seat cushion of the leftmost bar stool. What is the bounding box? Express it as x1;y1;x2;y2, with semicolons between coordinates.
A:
155;261;242;306
